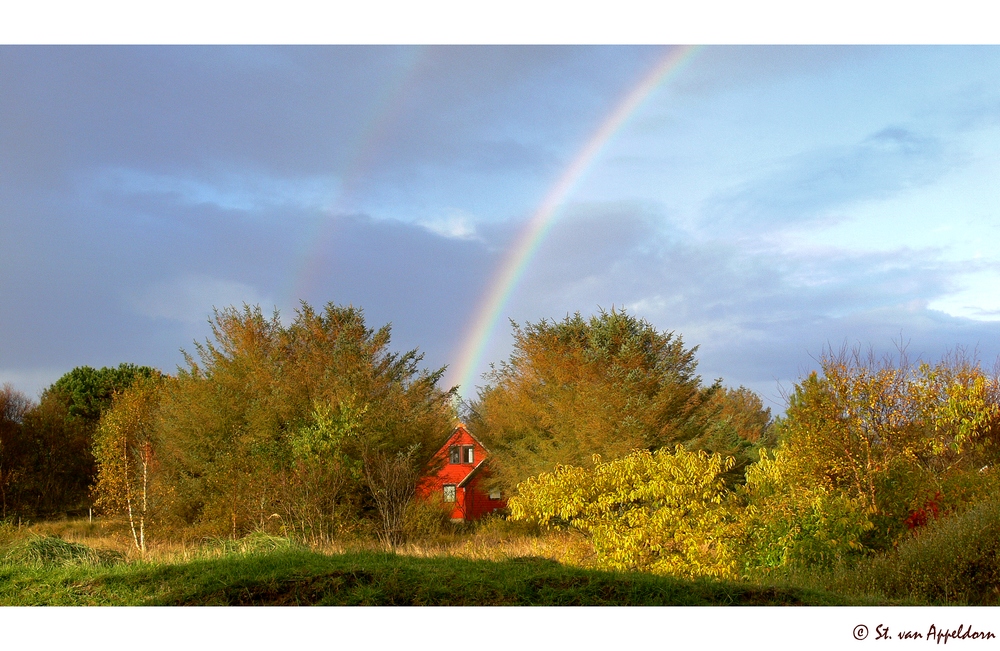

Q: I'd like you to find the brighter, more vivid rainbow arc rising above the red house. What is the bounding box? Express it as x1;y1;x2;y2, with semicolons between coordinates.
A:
456;46;700;397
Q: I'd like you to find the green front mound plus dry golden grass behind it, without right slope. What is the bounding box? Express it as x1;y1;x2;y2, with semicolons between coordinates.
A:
0;521;870;606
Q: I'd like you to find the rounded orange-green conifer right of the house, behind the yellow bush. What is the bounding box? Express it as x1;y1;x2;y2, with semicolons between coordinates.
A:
469;310;719;489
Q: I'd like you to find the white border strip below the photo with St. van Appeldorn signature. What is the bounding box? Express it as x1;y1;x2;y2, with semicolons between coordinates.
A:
0;606;1000;651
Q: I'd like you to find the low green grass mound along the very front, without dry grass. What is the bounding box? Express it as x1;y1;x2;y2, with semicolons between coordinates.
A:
0;548;867;606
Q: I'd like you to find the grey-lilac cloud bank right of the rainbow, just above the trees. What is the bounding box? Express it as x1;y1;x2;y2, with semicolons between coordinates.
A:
470;204;1000;408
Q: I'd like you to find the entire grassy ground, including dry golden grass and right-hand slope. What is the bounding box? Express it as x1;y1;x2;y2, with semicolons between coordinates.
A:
0;504;1000;606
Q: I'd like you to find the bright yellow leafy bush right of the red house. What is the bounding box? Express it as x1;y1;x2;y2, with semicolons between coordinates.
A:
509;446;738;578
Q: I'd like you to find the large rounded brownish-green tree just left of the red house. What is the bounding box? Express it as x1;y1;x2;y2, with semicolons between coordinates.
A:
160;303;454;536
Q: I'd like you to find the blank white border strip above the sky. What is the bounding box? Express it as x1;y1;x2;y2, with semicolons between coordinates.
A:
0;0;1000;44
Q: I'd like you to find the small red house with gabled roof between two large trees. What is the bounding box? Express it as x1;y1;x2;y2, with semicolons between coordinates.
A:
417;423;507;522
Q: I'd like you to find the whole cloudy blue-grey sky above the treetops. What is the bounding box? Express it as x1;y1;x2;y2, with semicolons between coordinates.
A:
0;45;1000;410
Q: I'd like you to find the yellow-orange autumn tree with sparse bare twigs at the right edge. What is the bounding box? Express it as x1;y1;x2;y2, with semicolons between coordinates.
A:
746;348;1000;567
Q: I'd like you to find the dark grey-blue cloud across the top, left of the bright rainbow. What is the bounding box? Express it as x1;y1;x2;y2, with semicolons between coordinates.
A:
0;46;659;206
